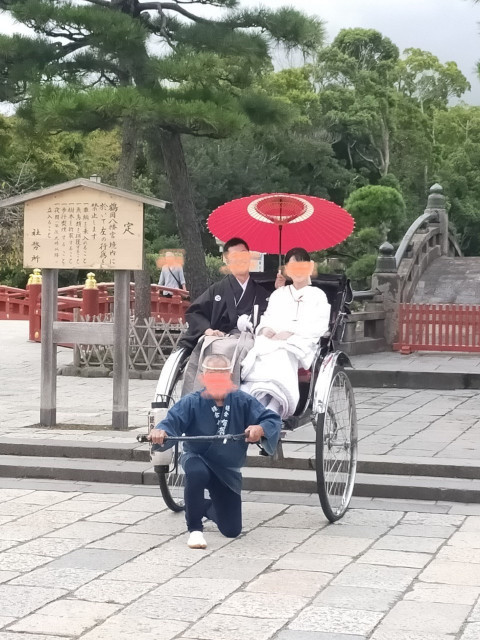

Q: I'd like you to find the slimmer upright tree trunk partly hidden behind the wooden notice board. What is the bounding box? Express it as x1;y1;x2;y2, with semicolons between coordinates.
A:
117;117;151;325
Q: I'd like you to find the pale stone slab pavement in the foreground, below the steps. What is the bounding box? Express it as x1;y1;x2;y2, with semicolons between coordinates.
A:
0;479;480;640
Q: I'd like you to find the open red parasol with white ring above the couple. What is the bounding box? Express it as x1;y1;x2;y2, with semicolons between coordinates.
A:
207;193;355;264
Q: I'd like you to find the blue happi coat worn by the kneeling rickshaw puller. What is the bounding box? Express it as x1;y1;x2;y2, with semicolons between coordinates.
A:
153;391;282;493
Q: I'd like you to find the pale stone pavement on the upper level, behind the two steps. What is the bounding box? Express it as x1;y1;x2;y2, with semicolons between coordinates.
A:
0;321;480;463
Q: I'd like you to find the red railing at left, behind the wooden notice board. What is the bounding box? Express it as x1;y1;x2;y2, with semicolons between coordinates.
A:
0;282;190;342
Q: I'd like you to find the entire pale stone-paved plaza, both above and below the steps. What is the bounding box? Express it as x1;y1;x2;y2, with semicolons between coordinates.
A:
0;321;480;640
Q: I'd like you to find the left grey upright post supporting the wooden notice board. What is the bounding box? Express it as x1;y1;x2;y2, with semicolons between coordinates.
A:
40;269;58;427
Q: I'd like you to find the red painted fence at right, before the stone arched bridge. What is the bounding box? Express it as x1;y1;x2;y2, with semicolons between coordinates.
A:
393;304;480;353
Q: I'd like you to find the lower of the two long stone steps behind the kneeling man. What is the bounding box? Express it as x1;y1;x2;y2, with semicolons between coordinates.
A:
0;455;480;503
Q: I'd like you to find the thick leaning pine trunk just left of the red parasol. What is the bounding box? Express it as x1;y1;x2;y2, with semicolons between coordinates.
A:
149;129;208;300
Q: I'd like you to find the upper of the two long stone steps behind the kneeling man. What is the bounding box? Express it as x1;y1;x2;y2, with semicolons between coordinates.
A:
0;436;480;479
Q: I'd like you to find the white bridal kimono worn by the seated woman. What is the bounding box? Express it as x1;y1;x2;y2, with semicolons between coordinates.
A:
241;285;330;418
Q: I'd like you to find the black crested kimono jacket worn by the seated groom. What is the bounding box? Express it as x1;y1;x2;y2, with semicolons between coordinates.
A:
178;274;270;351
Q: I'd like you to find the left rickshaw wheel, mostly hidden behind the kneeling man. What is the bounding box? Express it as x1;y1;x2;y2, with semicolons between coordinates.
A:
155;369;185;512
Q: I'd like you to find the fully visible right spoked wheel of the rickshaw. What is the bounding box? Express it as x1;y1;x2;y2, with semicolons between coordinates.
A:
313;367;358;522
